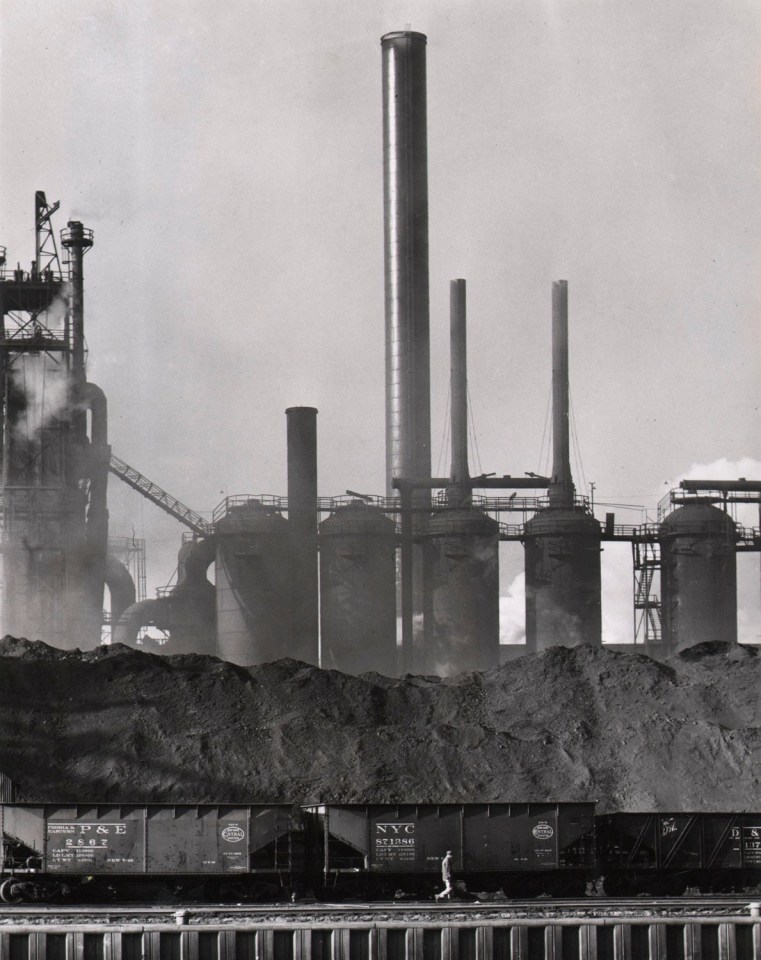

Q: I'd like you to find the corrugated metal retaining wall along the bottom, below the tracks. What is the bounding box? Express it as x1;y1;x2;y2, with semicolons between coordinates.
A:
0;918;761;960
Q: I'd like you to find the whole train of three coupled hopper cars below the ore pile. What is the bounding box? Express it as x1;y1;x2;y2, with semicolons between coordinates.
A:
0;802;761;903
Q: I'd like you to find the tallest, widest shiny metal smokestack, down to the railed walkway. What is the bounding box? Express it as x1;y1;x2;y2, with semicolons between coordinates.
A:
381;31;431;502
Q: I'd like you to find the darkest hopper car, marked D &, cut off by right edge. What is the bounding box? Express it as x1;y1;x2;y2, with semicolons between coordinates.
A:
596;812;761;895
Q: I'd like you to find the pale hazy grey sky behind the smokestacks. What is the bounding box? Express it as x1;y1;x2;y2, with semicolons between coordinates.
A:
0;0;761;635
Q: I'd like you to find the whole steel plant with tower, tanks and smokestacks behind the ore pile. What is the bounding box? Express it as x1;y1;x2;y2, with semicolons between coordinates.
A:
0;31;761;675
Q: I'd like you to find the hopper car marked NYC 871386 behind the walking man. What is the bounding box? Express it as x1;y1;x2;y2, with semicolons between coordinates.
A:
309;803;595;896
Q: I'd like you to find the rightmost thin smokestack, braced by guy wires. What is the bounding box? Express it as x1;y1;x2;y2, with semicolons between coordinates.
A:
549;280;576;509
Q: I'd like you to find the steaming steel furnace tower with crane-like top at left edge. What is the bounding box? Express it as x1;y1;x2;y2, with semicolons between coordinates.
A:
0;191;109;647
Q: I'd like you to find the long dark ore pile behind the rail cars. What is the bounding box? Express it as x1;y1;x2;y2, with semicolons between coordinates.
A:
0;637;761;811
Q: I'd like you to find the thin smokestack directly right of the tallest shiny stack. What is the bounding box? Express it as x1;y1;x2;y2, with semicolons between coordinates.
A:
447;280;471;507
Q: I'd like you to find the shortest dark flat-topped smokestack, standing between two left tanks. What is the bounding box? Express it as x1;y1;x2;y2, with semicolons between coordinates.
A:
285;407;318;664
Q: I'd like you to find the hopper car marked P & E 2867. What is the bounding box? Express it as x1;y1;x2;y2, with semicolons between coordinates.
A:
0;803;304;903
